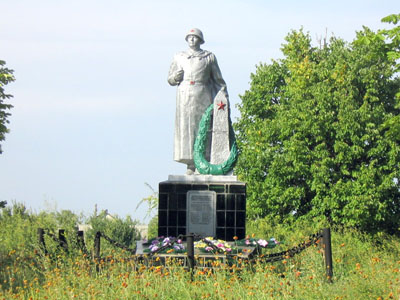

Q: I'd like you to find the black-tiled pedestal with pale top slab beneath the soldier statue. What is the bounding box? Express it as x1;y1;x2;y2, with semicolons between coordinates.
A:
158;175;246;241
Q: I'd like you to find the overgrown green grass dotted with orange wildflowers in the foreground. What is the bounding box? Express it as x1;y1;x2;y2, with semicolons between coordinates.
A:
0;204;400;300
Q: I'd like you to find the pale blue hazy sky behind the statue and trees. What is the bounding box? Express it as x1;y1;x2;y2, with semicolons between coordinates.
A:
0;0;400;222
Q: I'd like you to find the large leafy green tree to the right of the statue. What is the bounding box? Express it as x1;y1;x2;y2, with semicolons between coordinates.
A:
235;15;400;232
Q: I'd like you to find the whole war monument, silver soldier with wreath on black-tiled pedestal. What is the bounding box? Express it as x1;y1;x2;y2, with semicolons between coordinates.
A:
158;28;246;240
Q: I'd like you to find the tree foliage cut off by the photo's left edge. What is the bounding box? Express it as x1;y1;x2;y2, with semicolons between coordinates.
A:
0;60;15;154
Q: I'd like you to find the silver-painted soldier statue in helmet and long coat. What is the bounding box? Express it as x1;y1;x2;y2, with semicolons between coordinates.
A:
168;28;228;175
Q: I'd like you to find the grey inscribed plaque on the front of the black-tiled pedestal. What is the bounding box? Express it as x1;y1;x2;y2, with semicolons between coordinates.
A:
186;191;216;237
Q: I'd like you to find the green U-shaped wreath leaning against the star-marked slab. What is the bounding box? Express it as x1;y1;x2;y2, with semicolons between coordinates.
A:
193;104;238;175
